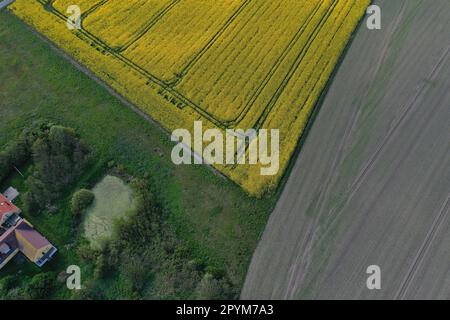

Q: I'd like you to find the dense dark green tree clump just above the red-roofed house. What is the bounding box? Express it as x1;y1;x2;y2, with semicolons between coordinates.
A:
0;120;90;214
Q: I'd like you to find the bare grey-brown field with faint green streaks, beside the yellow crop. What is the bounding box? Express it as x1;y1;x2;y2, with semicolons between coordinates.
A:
242;0;450;299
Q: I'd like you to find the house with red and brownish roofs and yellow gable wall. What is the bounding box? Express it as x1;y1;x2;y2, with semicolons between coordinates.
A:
0;193;57;269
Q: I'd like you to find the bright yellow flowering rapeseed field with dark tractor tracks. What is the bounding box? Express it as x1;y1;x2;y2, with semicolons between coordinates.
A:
10;0;370;195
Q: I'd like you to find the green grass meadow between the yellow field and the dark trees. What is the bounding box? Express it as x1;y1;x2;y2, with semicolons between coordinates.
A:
0;11;276;298
